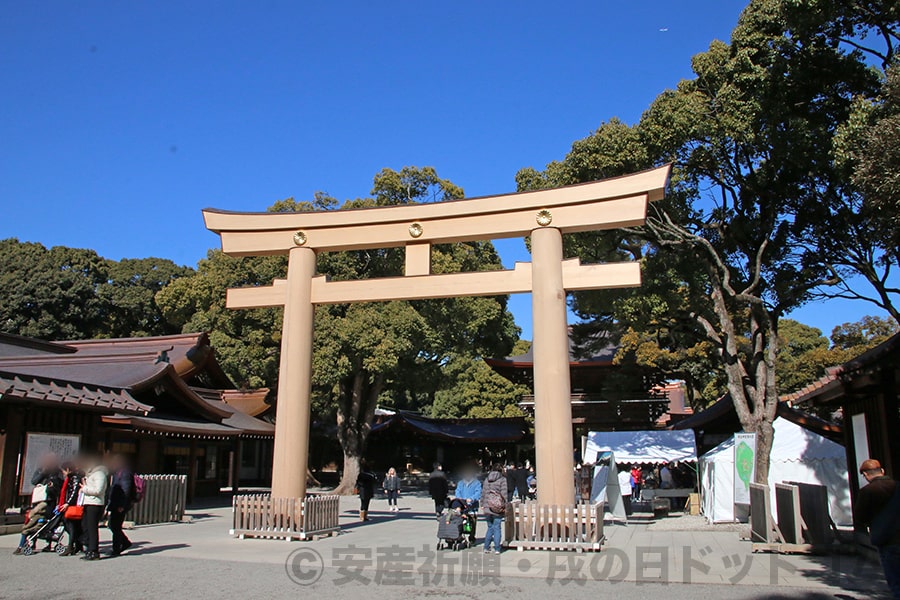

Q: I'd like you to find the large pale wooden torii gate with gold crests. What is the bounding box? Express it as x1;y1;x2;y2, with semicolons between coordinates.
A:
203;166;669;505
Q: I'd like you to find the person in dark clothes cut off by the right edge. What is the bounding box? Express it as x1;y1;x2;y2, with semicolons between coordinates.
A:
856;459;900;599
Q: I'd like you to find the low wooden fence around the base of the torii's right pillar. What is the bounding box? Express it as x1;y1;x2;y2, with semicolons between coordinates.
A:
504;501;604;552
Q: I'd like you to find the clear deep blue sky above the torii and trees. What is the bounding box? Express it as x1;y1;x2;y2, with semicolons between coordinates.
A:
0;0;873;338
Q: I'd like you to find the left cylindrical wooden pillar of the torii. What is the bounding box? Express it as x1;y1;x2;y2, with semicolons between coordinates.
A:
272;248;316;498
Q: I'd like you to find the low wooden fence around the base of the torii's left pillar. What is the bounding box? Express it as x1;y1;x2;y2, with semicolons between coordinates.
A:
231;494;341;540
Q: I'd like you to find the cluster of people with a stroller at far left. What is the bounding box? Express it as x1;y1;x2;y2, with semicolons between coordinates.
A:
14;452;136;560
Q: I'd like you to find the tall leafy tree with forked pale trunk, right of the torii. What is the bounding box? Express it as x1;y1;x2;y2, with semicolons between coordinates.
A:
517;0;894;479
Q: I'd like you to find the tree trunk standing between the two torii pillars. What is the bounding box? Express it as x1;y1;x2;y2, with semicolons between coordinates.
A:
334;369;384;495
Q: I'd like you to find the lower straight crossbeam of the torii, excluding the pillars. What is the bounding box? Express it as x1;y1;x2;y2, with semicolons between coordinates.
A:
226;259;641;308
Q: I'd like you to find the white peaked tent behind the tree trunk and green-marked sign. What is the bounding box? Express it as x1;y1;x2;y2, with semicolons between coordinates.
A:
700;417;853;525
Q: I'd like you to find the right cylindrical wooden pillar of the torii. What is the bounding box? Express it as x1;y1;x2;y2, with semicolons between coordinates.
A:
531;227;575;506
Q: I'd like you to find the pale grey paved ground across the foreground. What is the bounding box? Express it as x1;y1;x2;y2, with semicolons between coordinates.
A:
0;497;886;600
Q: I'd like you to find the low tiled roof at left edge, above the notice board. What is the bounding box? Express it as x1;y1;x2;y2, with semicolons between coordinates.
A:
0;371;153;415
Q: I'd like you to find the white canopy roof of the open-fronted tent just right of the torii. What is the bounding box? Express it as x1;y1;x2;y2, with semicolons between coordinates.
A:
583;429;697;464
